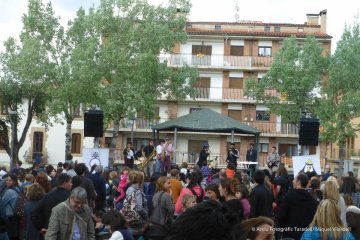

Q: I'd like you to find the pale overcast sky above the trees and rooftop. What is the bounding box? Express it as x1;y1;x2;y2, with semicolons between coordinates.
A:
0;0;360;52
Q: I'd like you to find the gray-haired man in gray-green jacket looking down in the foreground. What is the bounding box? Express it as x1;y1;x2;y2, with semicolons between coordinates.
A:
45;187;95;240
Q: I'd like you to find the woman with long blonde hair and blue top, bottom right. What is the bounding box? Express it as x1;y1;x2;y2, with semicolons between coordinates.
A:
301;199;355;240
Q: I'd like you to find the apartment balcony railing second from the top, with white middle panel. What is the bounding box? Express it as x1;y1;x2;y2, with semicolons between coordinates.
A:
194;87;280;101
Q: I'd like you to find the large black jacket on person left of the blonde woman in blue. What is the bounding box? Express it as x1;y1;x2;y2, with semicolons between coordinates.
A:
277;189;317;239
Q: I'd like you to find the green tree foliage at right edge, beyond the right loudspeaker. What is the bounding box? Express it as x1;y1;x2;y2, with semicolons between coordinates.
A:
318;22;360;148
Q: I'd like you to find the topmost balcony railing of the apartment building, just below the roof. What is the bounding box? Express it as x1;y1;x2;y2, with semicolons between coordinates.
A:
161;54;272;69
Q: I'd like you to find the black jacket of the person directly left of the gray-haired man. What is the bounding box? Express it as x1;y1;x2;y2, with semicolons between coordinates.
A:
31;187;70;231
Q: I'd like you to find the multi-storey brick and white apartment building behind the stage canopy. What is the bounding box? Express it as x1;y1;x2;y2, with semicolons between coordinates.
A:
118;10;331;170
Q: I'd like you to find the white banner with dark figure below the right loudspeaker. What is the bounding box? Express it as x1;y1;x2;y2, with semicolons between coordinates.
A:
292;155;321;176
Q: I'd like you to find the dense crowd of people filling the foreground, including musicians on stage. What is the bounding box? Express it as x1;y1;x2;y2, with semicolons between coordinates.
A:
0;140;360;240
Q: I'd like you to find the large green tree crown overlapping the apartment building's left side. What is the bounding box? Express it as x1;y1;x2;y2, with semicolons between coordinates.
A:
96;0;197;120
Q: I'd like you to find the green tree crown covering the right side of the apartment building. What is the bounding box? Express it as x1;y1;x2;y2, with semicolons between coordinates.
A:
245;36;327;123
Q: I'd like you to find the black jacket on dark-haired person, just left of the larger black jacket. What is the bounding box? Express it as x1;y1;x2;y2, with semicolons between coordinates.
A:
250;184;273;218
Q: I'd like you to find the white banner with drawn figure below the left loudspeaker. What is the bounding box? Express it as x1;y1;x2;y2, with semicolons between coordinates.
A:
83;148;109;168
